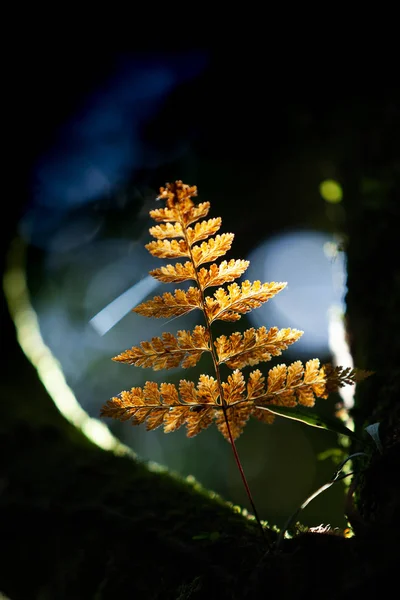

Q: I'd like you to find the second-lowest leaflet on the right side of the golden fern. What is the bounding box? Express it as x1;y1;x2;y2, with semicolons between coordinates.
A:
214;327;303;369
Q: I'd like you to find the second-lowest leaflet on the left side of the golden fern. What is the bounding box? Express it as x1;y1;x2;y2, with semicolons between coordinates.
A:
113;325;210;371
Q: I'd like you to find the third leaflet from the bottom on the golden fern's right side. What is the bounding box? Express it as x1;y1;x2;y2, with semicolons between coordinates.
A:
205;280;286;323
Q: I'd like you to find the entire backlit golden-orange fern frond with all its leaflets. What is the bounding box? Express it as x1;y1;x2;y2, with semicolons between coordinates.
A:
101;181;371;450
